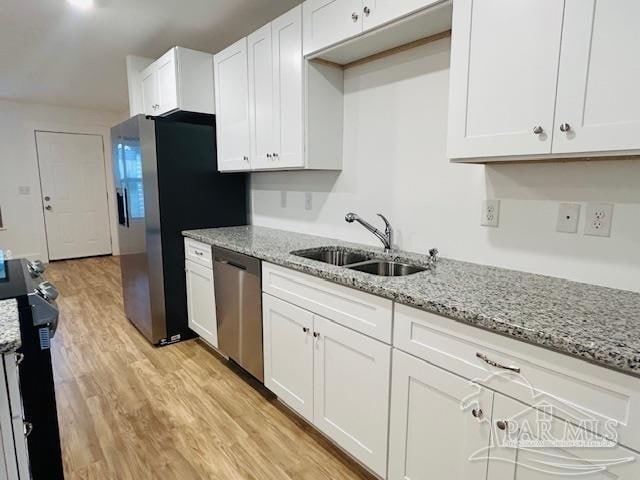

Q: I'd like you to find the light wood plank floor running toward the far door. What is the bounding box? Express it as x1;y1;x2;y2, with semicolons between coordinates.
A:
47;257;373;480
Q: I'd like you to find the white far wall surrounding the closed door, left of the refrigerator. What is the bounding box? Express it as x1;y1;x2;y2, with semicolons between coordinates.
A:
0;100;126;259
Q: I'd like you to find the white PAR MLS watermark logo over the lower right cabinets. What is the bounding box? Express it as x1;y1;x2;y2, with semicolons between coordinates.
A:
460;371;636;477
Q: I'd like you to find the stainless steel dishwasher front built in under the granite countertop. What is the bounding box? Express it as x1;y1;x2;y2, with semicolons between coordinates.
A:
213;247;264;382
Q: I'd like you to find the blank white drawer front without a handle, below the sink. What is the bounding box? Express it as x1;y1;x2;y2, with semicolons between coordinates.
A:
262;263;393;343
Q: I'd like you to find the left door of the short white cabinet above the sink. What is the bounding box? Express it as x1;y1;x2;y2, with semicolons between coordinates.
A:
302;0;363;55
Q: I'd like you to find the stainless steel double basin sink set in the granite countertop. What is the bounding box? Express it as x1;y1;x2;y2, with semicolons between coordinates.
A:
291;247;428;277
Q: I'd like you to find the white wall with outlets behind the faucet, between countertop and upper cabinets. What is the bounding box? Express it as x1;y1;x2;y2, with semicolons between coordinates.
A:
251;40;640;291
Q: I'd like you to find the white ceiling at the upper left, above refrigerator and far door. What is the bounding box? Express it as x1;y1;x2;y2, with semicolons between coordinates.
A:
0;0;300;112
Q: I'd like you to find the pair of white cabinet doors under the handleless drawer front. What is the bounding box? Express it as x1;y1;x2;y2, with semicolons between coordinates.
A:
262;293;391;477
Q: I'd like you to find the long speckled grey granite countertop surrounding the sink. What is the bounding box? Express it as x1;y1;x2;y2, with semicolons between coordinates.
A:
183;226;640;377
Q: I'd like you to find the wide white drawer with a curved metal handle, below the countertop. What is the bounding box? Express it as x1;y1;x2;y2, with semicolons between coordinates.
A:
393;305;640;449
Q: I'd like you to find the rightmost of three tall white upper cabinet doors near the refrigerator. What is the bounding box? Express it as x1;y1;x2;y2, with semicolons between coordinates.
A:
272;6;304;168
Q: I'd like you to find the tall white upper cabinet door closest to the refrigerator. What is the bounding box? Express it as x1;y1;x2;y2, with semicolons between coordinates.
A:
213;38;251;172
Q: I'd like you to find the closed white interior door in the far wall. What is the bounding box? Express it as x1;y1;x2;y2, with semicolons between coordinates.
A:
36;132;111;260
